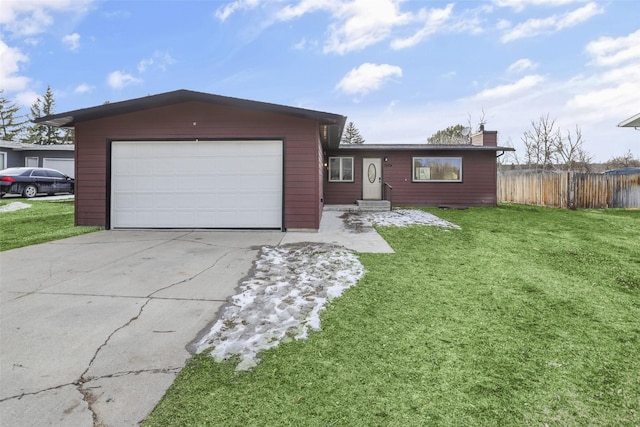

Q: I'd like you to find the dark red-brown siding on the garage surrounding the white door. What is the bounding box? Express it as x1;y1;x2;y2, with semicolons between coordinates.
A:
76;102;320;229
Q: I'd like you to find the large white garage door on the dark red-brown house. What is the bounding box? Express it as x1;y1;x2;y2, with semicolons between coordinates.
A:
111;140;283;229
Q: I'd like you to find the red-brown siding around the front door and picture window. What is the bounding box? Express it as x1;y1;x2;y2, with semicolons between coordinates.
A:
324;150;497;206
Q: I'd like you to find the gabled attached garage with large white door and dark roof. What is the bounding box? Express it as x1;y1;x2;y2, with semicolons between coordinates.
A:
35;90;346;231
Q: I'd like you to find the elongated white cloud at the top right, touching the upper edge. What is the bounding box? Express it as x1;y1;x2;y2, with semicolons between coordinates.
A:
501;2;604;43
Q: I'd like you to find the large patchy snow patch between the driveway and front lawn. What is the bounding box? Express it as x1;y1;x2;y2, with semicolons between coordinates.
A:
197;243;364;371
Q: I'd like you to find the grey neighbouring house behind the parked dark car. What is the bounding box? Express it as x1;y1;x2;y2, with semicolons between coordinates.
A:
0;141;75;178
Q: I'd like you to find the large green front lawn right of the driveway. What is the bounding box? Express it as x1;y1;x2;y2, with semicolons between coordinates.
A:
144;205;640;427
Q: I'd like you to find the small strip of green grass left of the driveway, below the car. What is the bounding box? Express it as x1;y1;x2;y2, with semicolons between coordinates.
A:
0;199;99;251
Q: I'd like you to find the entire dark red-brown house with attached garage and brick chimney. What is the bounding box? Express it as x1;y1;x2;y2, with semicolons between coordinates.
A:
36;90;507;231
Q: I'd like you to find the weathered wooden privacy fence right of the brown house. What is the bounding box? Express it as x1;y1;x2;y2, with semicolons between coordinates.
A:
498;172;640;209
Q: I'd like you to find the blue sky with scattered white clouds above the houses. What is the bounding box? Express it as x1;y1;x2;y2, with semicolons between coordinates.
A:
0;0;640;162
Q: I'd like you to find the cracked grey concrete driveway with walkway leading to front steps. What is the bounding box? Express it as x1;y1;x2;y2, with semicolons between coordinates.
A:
0;212;392;427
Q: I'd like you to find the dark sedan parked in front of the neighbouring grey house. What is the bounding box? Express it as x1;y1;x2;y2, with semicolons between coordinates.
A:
0;168;75;197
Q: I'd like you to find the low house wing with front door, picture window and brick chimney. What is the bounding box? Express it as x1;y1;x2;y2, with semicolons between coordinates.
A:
325;129;513;207
